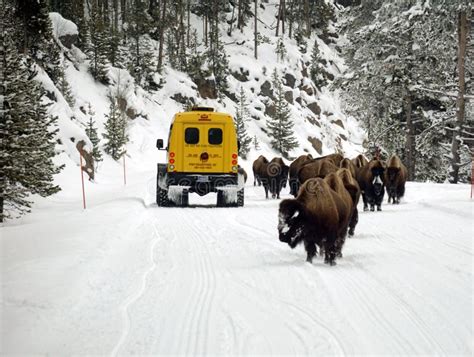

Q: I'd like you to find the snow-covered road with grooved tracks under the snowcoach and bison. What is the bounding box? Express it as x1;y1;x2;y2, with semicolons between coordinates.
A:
0;175;474;356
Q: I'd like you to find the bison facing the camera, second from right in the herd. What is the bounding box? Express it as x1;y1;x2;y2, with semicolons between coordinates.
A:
357;159;385;211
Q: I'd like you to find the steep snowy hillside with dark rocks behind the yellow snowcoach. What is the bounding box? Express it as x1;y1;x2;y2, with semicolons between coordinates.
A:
41;1;364;183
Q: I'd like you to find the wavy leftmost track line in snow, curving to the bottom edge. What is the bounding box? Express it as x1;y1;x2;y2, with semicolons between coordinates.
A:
111;213;160;356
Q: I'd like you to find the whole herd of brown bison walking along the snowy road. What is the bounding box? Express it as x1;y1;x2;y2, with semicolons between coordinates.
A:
252;153;407;265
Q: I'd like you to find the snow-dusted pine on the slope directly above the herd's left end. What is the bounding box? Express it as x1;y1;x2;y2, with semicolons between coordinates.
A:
267;69;298;157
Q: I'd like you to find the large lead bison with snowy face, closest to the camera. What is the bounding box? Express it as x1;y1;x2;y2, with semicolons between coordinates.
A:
278;178;347;265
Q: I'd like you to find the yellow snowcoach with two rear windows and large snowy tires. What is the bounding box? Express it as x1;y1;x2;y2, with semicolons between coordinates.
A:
156;107;244;207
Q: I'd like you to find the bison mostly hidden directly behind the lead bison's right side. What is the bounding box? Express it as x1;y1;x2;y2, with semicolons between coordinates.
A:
324;172;353;257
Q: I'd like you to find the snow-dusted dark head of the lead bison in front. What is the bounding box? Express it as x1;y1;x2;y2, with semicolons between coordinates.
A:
278;199;304;248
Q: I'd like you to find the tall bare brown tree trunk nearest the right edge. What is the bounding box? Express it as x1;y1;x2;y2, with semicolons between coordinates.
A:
450;10;468;183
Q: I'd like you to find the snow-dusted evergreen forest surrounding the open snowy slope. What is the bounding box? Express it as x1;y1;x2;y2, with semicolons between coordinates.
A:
0;0;474;221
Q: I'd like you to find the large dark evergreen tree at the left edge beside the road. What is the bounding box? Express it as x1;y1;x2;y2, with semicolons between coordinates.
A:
0;29;61;221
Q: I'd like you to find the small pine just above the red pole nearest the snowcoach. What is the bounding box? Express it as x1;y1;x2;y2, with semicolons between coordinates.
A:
102;97;128;160
